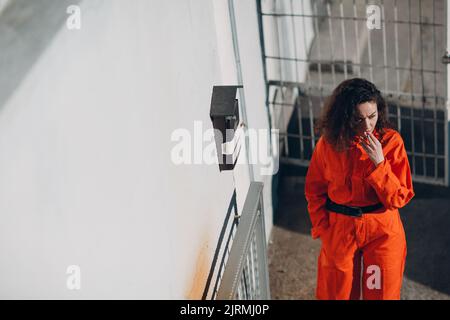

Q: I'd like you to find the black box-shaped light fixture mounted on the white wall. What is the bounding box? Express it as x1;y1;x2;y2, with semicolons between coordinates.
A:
209;86;243;171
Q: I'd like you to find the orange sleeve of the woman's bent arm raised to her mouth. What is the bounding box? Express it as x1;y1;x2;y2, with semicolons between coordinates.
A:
366;134;415;209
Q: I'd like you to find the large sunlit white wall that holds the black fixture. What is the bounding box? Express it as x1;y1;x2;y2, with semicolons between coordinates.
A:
0;0;272;299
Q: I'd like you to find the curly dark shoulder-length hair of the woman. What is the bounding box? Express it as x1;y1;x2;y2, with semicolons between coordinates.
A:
314;78;394;151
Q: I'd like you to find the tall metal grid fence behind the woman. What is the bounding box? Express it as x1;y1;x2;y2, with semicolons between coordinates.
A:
257;0;449;185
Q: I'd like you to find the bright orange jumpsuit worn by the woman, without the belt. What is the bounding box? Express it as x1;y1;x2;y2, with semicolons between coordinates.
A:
305;129;415;299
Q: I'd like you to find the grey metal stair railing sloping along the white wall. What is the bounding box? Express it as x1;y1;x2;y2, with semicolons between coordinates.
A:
215;182;270;300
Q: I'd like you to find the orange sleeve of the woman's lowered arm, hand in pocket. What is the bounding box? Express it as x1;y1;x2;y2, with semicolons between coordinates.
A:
305;137;329;239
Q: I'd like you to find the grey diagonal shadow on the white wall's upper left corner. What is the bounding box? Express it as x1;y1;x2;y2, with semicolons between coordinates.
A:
0;0;82;109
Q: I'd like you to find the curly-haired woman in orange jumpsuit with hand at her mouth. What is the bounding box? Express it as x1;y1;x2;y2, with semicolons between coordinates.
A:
305;78;415;299
